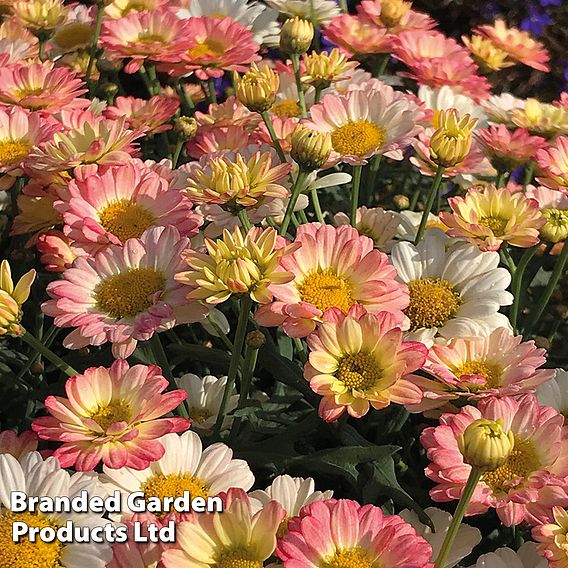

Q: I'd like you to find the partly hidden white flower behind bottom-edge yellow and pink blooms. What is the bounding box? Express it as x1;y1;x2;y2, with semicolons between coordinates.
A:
249;475;333;518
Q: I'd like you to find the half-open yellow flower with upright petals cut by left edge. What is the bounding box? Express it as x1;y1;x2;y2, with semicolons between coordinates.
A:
0;260;36;337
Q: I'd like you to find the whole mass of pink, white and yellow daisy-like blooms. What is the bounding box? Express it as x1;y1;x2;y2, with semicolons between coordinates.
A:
0;0;568;568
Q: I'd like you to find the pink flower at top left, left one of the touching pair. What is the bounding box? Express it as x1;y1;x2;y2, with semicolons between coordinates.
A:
99;7;192;73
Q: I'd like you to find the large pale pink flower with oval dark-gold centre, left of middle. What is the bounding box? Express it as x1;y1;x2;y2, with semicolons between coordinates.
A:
42;227;206;358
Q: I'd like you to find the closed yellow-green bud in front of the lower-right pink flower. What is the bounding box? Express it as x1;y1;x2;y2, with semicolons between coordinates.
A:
457;418;515;471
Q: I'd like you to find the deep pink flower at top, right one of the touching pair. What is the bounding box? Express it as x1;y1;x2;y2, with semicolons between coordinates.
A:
164;16;261;80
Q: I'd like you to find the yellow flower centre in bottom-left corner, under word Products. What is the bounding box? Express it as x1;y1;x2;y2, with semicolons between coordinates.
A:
0;509;63;568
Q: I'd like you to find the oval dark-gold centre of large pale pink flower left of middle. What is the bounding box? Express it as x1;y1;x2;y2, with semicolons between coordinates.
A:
95;268;166;319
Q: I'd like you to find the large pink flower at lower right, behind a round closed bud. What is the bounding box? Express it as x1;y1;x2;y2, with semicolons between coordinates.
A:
420;394;568;526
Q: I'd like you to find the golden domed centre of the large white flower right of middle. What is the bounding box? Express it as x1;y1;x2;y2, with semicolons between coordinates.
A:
405;278;463;331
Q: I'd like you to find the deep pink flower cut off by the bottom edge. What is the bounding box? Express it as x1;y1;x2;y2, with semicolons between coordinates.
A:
276;499;434;568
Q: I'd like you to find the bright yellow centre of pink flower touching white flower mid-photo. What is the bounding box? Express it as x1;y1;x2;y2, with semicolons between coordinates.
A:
297;269;355;313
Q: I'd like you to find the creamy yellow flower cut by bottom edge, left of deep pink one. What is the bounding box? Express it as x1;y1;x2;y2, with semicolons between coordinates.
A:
162;489;284;568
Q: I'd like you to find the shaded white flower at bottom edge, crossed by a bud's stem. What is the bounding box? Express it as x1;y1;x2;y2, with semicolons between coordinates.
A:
399;507;481;568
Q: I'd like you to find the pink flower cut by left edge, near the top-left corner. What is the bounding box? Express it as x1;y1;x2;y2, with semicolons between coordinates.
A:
0;63;89;113
